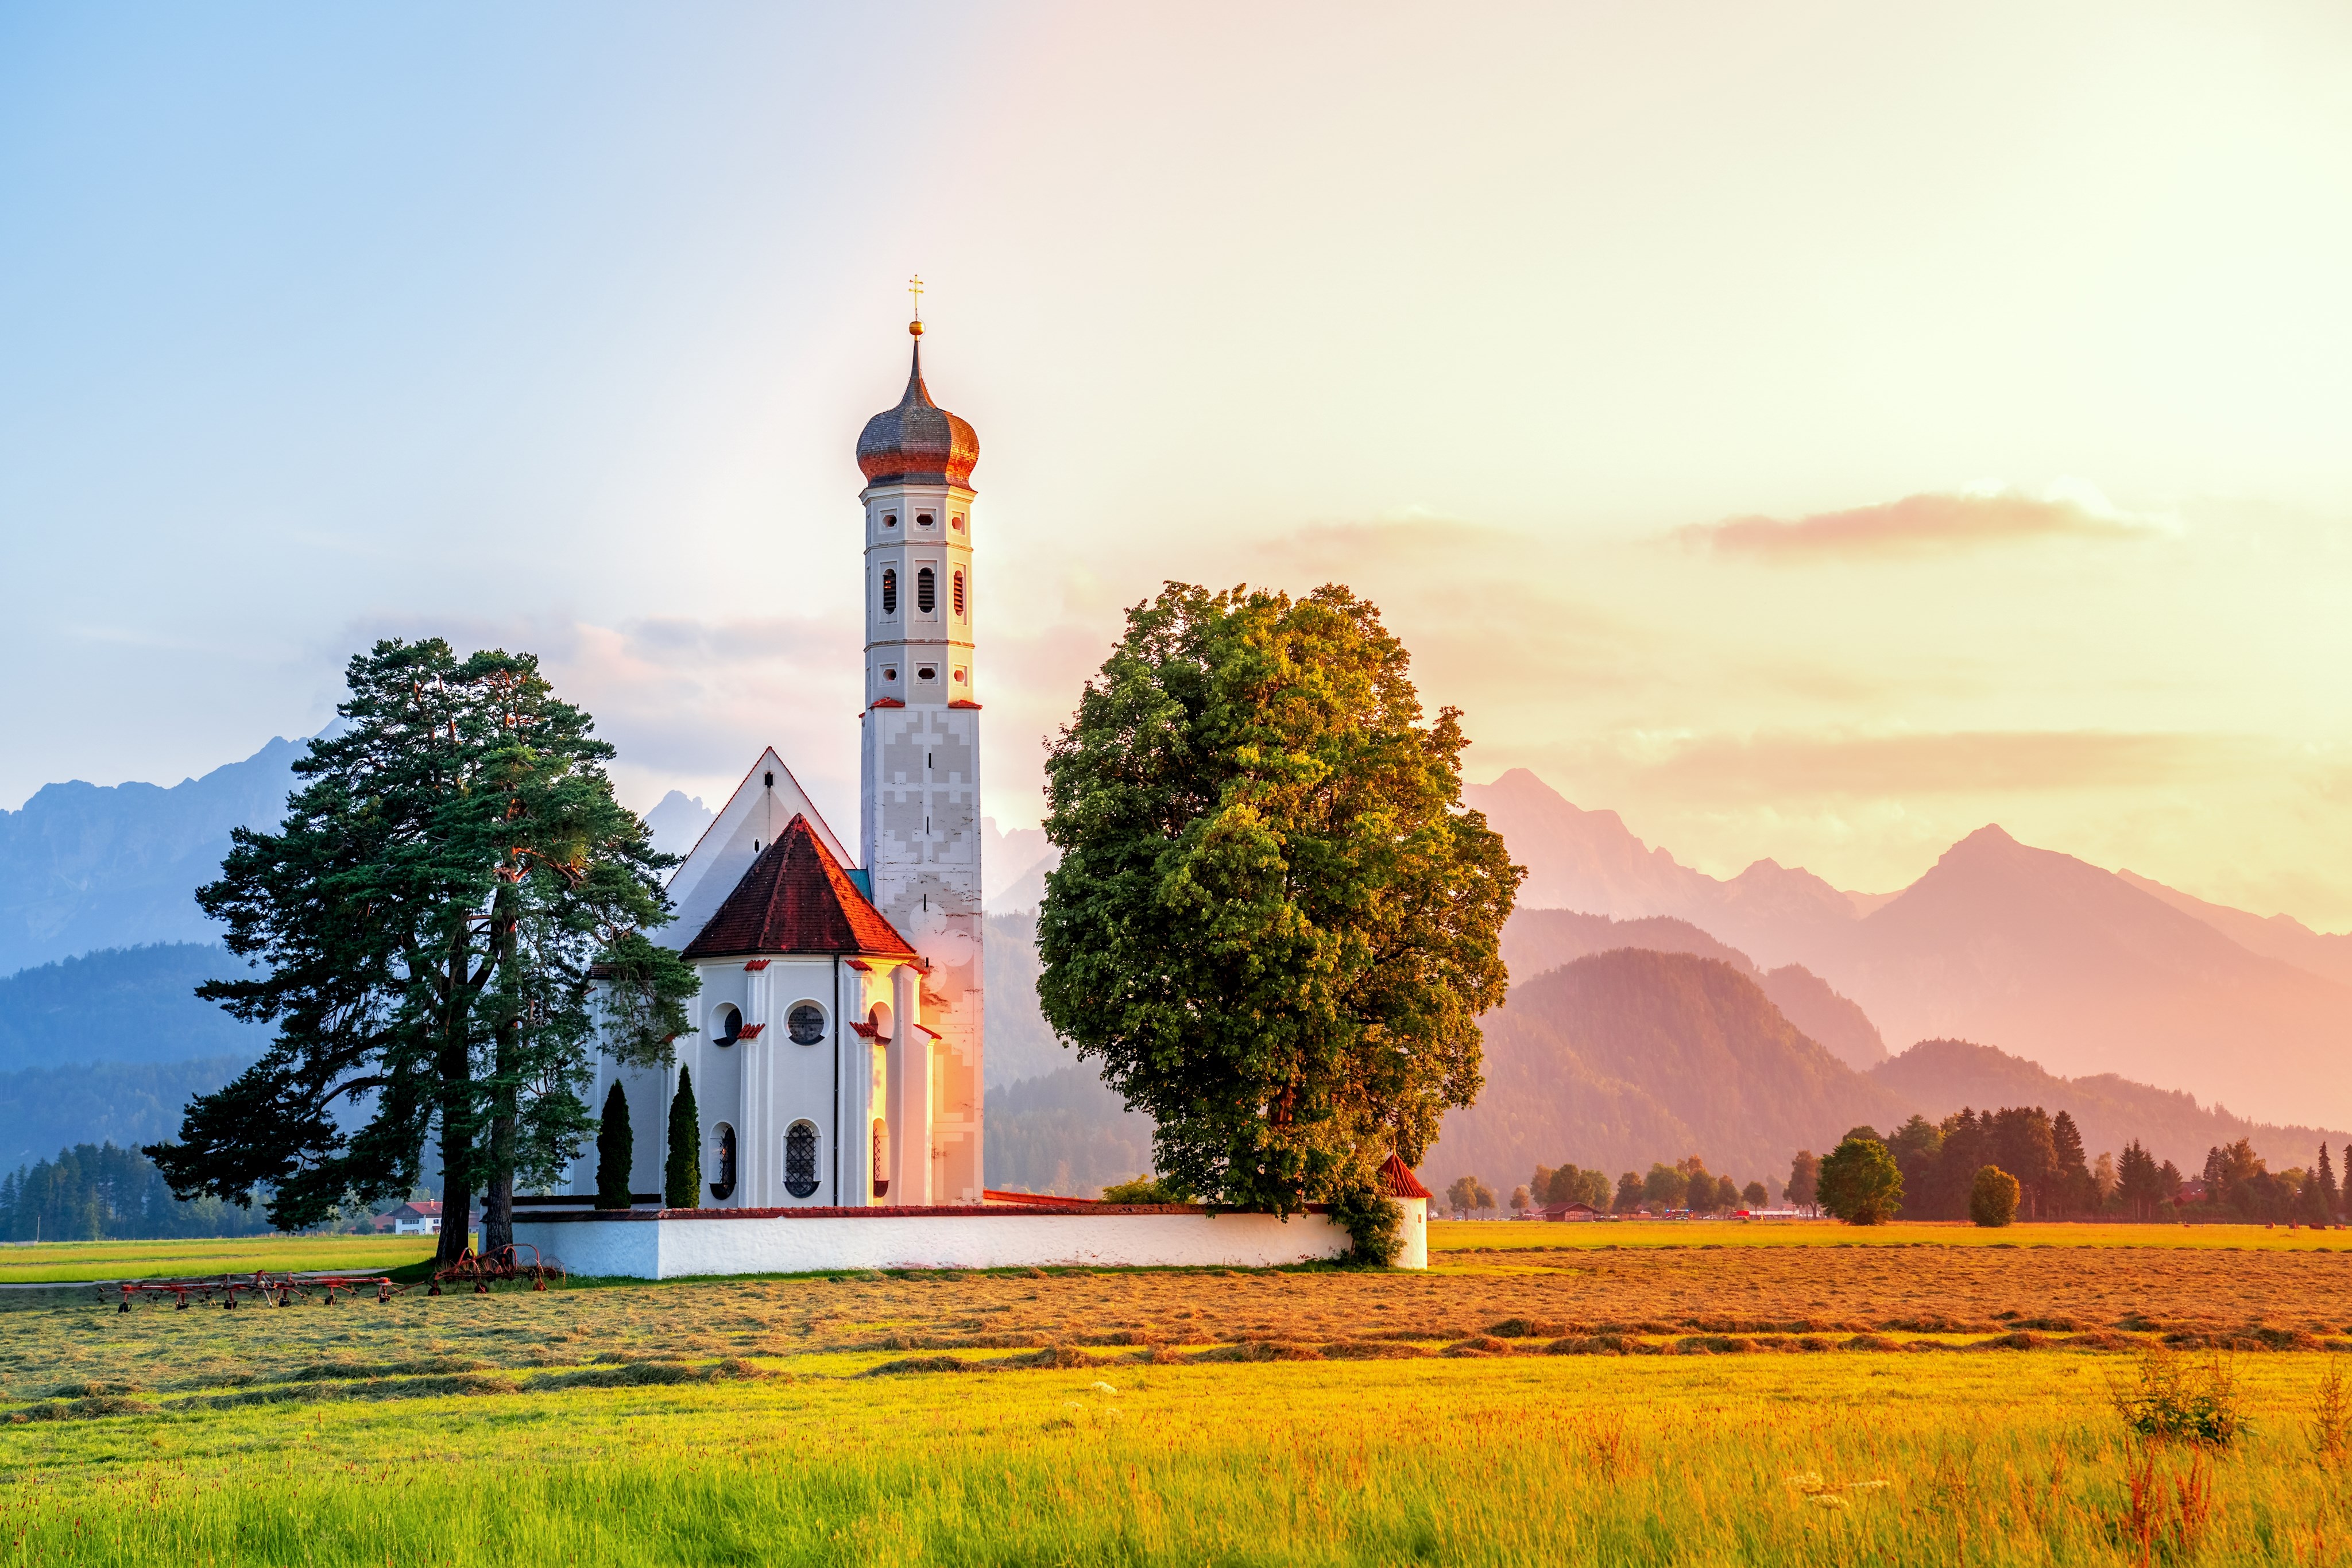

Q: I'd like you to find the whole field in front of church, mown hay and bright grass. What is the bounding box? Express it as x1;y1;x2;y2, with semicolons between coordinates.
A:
0;1225;2352;1563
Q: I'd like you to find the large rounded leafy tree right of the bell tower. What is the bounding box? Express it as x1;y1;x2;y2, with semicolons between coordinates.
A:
1037;583;1524;1250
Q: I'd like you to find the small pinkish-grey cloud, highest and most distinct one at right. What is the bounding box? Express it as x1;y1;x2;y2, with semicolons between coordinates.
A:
1677;482;2159;564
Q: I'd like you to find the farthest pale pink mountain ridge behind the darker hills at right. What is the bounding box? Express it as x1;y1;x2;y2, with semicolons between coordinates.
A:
1463;769;2352;1121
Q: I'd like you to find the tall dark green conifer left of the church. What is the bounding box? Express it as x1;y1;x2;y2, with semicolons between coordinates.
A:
148;640;694;1263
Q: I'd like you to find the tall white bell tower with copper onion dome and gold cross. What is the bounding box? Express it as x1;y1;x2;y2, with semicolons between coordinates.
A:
858;282;985;1203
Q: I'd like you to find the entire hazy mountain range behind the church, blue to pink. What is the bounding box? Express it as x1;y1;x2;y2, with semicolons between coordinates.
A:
0;738;2352;1194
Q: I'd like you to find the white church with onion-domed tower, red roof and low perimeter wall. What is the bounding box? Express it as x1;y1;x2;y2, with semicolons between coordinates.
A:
515;320;1428;1279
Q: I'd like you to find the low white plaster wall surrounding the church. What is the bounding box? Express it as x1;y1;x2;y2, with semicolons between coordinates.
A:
515;1206;1364;1279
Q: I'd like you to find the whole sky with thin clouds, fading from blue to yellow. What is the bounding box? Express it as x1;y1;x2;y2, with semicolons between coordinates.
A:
0;2;2352;928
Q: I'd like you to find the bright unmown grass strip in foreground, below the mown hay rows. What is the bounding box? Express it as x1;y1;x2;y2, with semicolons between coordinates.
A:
0;1354;2352;1566
